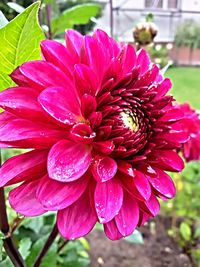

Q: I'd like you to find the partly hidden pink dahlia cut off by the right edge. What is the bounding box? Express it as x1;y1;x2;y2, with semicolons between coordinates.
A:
177;103;200;162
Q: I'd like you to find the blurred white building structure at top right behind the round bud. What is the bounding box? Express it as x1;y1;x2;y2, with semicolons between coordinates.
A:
97;0;200;42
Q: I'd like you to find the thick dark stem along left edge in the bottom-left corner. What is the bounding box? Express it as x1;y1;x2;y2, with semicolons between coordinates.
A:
0;150;26;267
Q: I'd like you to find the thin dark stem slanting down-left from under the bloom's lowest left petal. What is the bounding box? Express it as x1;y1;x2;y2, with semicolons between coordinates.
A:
33;224;58;267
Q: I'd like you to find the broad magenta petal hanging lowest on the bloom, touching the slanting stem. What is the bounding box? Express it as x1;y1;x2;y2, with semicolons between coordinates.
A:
57;192;97;240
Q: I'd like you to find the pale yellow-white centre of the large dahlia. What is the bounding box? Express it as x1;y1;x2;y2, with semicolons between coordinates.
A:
120;110;139;132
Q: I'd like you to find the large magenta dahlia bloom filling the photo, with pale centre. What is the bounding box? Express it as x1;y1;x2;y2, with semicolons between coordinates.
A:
0;30;188;240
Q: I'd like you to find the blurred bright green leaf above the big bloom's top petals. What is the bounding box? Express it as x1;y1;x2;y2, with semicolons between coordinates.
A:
51;4;101;35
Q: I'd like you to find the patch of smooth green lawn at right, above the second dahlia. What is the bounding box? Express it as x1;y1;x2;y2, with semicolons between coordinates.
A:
165;67;200;110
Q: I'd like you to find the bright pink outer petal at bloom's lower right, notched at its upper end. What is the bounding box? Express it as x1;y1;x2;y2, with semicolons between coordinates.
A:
148;169;176;198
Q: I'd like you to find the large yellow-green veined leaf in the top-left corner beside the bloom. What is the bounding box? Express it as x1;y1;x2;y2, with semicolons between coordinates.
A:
0;2;44;91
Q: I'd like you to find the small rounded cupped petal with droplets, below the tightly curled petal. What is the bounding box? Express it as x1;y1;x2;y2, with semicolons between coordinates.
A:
91;157;117;182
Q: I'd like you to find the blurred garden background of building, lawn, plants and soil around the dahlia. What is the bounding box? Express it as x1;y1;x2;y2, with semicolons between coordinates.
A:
0;0;200;267
